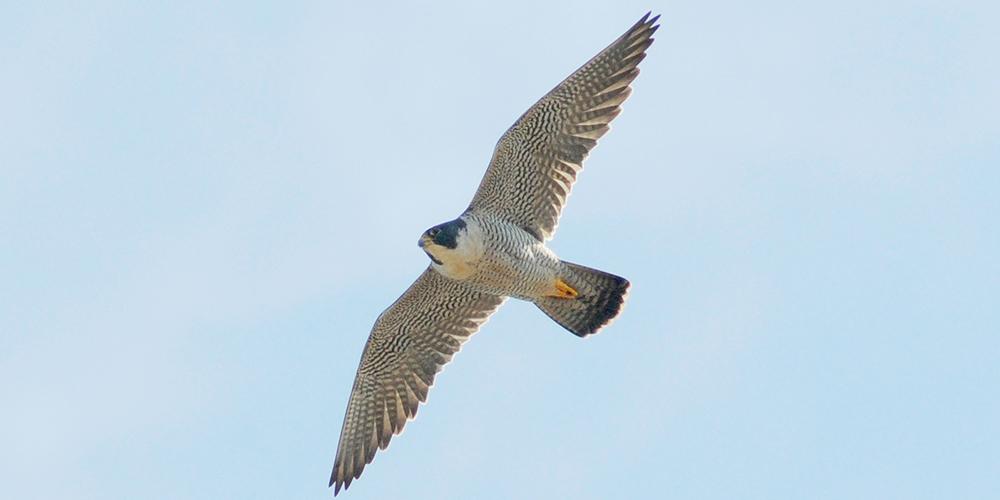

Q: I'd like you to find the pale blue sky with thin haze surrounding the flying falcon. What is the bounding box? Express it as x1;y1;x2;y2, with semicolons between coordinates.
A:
0;0;1000;500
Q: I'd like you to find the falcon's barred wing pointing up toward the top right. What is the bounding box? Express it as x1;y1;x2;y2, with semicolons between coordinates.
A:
469;14;660;241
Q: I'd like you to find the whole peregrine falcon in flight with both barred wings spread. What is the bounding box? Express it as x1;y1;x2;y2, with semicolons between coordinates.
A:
330;13;659;495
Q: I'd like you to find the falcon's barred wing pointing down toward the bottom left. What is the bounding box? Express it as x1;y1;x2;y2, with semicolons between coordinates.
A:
330;267;506;494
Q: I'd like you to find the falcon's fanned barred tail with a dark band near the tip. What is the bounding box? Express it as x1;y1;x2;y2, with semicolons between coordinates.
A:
535;261;629;337
